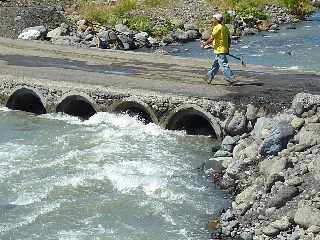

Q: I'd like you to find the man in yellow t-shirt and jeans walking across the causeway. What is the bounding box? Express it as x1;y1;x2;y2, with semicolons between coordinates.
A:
201;13;236;85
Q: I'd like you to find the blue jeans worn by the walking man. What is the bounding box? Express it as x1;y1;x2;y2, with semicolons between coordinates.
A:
208;54;235;82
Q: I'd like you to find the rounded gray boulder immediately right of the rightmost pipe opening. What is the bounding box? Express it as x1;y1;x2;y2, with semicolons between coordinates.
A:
225;111;247;136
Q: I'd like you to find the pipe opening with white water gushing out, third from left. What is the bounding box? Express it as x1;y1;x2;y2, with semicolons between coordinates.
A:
115;102;153;124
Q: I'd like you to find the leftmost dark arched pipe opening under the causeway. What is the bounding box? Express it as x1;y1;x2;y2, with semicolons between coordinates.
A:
6;88;47;115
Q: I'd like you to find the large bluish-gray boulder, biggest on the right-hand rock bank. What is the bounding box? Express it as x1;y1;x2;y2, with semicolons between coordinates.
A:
259;121;295;156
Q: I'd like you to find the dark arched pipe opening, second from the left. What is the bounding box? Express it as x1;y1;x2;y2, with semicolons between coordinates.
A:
57;96;97;120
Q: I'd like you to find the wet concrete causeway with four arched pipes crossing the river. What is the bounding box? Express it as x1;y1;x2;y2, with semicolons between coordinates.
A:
0;38;320;136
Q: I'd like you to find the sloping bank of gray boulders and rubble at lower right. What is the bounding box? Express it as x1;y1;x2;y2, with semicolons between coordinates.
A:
204;93;320;240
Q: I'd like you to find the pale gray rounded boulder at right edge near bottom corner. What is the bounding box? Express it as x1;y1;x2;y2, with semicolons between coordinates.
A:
294;206;320;228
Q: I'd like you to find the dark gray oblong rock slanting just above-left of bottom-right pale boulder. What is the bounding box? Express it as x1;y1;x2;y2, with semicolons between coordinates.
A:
268;186;299;208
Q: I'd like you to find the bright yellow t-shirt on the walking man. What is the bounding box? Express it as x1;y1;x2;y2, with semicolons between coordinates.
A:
211;24;230;54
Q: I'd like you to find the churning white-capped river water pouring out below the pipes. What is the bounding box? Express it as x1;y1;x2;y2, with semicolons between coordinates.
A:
0;108;227;240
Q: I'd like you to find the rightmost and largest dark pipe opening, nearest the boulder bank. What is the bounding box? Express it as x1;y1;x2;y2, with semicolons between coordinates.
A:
167;111;217;138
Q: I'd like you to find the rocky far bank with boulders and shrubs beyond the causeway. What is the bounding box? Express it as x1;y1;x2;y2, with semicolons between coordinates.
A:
0;0;316;50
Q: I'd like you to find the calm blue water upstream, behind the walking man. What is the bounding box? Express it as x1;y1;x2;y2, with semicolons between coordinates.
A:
164;12;320;73
